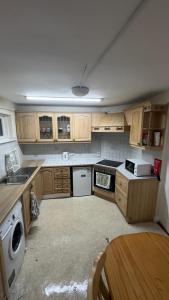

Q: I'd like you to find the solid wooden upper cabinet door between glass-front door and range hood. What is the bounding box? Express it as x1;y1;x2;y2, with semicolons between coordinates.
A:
73;113;91;141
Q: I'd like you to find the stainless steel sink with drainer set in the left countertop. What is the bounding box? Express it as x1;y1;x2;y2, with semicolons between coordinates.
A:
0;167;37;185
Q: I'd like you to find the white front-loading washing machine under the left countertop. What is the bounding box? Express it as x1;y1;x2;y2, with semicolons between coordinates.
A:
0;201;25;296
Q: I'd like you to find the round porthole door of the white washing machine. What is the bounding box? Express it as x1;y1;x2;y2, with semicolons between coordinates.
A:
9;220;24;259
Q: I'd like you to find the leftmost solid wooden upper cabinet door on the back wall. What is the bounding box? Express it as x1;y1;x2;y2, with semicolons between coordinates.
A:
16;113;37;142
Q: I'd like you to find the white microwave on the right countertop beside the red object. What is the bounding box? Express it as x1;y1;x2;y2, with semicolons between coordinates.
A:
125;159;152;177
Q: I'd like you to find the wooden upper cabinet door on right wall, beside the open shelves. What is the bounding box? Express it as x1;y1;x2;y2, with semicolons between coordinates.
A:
130;107;143;146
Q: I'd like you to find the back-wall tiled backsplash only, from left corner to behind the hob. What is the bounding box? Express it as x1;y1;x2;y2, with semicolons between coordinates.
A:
21;133;131;161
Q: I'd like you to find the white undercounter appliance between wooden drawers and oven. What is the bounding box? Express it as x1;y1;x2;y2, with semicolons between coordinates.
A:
73;167;92;197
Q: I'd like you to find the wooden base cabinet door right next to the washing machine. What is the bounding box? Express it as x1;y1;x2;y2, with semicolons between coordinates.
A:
22;186;31;235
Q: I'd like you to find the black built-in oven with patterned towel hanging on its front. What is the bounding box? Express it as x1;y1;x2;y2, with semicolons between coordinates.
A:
94;165;116;192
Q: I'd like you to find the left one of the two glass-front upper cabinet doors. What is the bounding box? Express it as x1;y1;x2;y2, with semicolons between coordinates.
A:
38;113;54;142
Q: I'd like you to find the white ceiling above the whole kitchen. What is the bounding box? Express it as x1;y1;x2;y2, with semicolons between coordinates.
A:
0;0;169;106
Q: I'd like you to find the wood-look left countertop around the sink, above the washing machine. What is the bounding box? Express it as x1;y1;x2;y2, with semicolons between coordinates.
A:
0;160;43;223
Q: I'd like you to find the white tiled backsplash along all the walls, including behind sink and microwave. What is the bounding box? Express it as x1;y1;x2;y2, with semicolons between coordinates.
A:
0;133;161;178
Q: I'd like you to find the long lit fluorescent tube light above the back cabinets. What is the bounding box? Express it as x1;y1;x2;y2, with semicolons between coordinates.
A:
26;96;103;103
